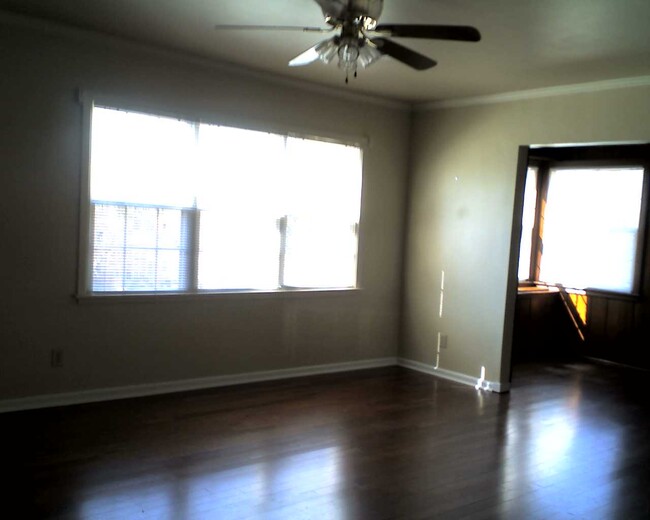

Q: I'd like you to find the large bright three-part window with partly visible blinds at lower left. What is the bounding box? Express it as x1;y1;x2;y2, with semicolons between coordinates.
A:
80;106;362;294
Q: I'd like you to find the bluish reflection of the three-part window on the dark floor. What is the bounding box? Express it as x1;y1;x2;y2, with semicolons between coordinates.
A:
79;446;347;520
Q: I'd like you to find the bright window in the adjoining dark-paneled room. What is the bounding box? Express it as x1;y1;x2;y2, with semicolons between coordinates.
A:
519;147;646;294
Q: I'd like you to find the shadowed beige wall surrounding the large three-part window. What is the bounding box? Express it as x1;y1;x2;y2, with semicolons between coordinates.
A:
0;21;410;400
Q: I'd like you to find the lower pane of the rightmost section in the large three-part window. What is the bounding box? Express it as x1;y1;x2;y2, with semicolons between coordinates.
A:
284;217;357;288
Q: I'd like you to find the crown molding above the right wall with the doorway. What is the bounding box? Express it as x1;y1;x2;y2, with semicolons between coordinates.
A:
413;76;650;112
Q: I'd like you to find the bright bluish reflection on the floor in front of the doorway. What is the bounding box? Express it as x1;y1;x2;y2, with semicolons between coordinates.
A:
500;364;624;519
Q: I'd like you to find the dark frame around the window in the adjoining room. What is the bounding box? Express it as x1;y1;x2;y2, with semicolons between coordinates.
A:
519;148;650;300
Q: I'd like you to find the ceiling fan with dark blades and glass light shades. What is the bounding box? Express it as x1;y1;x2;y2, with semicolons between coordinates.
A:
215;0;481;83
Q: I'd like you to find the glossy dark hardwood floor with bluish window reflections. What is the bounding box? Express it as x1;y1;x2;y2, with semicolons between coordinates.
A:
0;362;650;520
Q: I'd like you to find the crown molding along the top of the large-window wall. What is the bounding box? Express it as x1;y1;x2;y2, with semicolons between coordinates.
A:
0;9;404;112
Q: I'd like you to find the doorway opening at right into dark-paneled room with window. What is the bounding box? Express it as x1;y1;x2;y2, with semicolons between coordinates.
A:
509;144;650;375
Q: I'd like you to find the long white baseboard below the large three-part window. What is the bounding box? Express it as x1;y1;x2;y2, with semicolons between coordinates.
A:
0;357;397;413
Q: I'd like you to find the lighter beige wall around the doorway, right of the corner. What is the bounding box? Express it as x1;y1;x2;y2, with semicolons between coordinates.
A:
400;87;650;382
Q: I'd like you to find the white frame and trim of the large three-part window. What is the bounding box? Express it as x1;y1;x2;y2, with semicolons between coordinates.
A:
74;90;370;303
